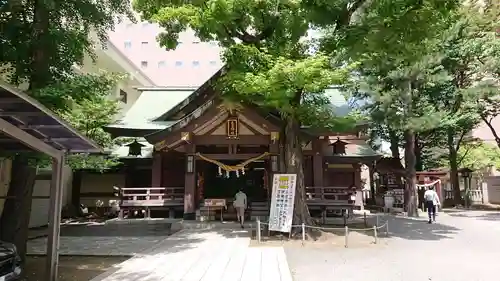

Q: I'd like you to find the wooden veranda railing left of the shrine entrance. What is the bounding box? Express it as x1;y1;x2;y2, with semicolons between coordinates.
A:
115;187;184;207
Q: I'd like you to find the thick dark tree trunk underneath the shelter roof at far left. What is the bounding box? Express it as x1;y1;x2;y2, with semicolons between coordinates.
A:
0;155;36;263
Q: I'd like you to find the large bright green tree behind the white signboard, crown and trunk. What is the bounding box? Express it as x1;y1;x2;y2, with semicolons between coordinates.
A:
134;0;365;224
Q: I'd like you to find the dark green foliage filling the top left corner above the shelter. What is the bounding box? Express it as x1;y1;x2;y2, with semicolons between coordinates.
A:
0;0;133;88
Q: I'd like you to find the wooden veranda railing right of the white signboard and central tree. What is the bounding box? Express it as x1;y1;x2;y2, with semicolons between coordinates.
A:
306;186;354;205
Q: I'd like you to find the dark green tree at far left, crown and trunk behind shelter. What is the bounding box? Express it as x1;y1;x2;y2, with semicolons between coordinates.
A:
0;0;133;261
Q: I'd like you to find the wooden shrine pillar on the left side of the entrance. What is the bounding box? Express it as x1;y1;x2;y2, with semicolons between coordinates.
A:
184;143;196;220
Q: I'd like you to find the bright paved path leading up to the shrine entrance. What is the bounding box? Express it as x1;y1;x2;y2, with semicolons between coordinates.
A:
92;230;292;281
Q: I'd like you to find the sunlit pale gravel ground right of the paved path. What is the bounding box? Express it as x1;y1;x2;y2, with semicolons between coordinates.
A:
285;211;500;281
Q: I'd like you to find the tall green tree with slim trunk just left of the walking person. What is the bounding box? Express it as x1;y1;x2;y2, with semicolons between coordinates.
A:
323;0;458;216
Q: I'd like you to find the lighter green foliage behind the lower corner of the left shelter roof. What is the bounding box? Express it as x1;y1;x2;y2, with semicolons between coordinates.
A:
38;73;123;170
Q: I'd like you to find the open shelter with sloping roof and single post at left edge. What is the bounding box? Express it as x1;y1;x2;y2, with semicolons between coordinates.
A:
0;82;102;281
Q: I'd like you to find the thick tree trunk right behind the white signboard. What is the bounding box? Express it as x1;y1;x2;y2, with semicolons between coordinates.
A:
285;116;314;225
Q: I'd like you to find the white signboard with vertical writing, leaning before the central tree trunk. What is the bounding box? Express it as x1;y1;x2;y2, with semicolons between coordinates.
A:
269;174;297;232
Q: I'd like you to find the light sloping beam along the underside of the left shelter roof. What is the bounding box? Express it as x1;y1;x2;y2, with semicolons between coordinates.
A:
0;118;64;158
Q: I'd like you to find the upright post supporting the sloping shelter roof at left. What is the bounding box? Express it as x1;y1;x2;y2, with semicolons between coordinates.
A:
44;154;65;281
